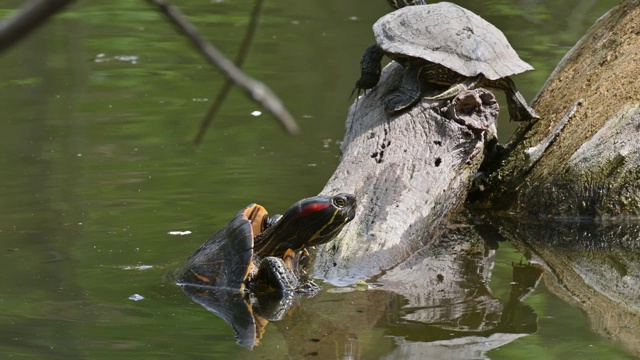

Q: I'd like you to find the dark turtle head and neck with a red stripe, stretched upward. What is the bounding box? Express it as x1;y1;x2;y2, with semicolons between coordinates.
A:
254;194;356;256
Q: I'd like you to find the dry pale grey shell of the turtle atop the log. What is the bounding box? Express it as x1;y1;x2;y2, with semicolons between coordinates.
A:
373;2;533;80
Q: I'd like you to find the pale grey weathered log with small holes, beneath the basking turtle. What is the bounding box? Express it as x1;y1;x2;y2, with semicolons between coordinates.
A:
314;63;498;283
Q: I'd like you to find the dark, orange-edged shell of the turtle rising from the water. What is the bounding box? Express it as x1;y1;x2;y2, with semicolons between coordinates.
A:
179;204;268;290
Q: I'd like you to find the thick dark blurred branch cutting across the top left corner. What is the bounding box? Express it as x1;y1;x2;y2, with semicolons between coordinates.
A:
0;0;73;52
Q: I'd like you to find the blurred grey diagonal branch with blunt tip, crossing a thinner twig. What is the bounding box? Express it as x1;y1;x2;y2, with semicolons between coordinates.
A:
148;0;299;134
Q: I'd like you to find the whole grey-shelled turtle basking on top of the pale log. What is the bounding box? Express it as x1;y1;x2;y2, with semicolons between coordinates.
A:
354;0;540;121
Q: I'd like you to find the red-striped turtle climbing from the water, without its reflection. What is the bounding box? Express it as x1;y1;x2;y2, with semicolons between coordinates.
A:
179;194;356;291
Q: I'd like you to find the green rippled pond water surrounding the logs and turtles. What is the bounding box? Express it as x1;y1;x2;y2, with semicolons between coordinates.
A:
0;0;637;359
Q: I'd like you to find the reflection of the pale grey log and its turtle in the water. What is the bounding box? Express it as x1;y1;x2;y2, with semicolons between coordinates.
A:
268;226;542;359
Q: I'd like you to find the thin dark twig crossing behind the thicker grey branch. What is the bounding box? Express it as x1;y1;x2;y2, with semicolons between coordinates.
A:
193;0;264;146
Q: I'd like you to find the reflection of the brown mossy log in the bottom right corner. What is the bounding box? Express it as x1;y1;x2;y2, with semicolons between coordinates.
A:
497;219;640;356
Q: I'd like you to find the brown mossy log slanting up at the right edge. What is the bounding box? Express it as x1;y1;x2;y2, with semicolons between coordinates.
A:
474;0;640;218
